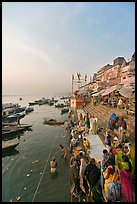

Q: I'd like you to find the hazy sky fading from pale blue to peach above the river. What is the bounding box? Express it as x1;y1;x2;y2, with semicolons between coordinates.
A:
2;2;135;96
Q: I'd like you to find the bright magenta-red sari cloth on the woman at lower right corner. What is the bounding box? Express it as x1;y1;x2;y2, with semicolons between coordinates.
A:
120;169;134;202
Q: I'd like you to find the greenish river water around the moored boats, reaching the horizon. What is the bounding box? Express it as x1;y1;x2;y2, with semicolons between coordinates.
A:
2;96;70;202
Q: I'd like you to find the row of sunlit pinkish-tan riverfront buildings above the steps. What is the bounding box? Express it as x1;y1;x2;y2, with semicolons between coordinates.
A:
79;53;135;93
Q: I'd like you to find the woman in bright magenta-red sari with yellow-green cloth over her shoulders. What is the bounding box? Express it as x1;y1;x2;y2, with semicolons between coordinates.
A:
120;155;134;202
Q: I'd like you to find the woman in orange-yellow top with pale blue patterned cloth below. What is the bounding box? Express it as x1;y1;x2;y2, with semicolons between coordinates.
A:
103;165;120;202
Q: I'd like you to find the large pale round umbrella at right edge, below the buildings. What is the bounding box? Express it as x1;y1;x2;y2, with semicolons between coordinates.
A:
119;86;135;98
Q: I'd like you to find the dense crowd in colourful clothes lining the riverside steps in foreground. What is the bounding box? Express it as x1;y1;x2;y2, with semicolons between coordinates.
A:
49;109;135;202
